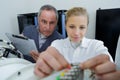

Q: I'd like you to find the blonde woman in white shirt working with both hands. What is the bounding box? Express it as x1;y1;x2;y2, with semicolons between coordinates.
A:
31;7;120;80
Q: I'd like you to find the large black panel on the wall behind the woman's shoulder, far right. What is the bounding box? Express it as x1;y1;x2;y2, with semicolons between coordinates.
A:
95;8;120;60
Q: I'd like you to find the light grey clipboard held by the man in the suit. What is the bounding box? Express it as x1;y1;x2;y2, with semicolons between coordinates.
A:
6;33;37;56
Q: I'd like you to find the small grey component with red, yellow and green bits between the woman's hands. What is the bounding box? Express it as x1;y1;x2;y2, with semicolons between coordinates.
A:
56;64;84;80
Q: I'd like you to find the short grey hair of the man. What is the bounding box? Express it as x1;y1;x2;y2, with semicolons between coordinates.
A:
38;4;58;20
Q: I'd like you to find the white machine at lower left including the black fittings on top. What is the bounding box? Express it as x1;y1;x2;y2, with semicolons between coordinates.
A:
0;40;39;80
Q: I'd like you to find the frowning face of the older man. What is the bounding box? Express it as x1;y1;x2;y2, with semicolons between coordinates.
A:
38;10;57;37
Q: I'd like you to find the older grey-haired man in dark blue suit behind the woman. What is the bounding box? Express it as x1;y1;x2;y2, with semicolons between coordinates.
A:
22;5;63;62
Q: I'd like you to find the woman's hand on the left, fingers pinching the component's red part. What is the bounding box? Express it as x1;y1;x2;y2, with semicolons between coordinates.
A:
34;47;68;77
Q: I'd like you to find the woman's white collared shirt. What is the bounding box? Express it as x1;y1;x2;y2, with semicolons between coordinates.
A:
51;37;113;63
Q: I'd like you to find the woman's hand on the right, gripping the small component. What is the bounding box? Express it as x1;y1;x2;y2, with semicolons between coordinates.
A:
80;54;120;80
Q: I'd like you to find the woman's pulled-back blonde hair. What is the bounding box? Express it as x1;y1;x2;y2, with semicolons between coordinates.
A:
65;7;89;23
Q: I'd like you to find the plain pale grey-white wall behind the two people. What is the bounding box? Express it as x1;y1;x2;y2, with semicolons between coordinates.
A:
0;0;120;39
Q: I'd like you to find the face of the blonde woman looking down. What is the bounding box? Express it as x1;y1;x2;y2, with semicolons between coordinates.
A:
66;15;88;42
